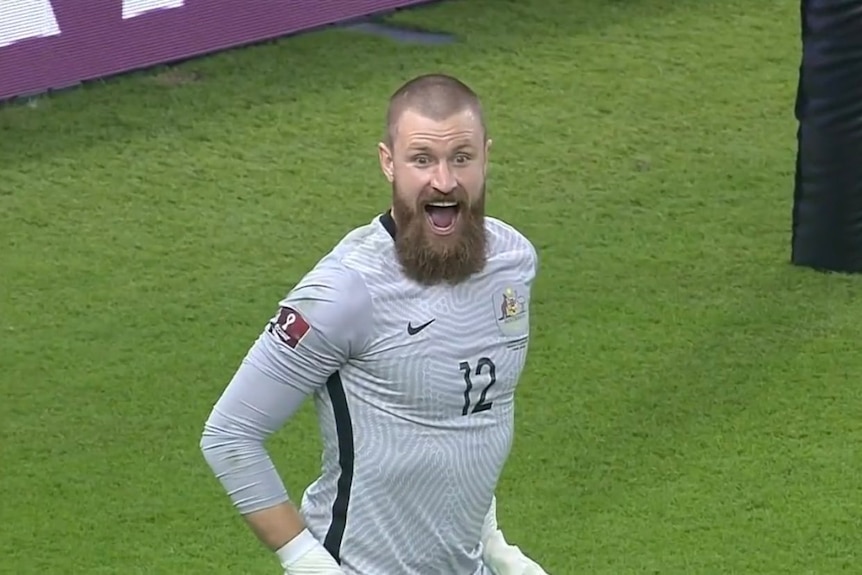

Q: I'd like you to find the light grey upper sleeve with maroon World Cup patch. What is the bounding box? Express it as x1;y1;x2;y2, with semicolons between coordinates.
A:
245;260;371;393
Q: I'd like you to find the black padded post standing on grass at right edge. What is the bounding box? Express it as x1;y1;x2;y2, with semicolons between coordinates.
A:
791;0;862;273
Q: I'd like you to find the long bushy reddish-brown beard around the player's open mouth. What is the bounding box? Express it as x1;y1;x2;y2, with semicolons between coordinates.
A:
392;182;487;285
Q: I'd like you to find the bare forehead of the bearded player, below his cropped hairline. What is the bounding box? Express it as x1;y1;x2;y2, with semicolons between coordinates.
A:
395;109;483;148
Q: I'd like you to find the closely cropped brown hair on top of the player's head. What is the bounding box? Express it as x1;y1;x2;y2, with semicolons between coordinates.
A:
386;74;485;147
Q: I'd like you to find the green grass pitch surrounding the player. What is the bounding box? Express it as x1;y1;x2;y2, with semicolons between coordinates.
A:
0;0;862;575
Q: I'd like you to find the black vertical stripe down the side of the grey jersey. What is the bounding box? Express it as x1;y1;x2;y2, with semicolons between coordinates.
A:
323;372;354;563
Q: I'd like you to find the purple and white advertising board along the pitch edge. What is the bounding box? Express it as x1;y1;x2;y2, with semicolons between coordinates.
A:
0;0;428;100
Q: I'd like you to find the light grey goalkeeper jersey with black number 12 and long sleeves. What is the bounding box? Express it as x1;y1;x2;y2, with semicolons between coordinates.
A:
201;214;537;575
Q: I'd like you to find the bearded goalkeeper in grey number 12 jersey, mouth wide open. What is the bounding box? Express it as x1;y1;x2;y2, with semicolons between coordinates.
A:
201;75;545;575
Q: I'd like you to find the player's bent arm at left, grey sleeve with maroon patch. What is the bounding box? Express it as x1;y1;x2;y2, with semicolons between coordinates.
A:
200;263;370;564
